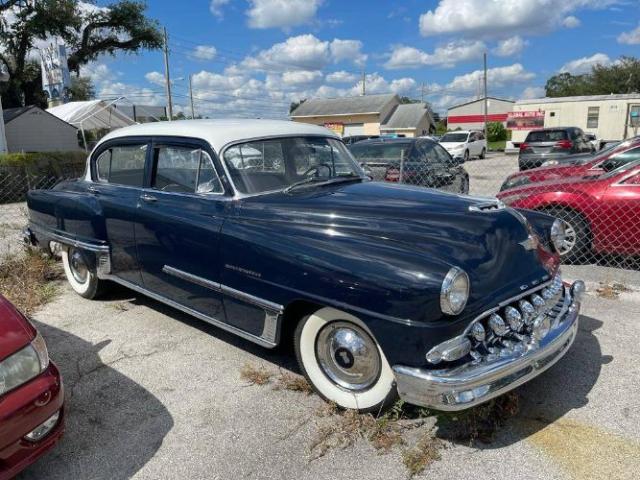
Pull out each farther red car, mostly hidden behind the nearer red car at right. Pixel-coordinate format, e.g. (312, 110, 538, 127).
(500, 137, 640, 191)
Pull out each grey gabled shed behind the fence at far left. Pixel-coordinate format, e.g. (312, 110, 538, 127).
(2, 105, 80, 152)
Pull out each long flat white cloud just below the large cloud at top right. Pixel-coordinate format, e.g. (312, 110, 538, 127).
(384, 41, 486, 70)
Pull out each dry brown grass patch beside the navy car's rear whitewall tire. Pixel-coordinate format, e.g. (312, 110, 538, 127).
(0, 249, 62, 315)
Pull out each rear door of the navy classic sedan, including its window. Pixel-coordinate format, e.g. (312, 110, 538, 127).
(88, 138, 150, 285)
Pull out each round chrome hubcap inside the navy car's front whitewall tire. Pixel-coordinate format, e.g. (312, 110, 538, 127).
(316, 321, 381, 391)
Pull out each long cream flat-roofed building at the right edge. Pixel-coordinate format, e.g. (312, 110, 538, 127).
(512, 93, 640, 144)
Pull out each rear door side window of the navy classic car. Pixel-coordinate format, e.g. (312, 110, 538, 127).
(96, 144, 147, 187)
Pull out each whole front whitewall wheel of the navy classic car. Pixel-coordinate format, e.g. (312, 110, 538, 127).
(294, 308, 398, 412)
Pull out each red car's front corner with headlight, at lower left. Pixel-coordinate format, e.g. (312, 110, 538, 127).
(0, 295, 64, 480)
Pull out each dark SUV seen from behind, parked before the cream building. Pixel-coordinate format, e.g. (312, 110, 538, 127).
(518, 127, 594, 170)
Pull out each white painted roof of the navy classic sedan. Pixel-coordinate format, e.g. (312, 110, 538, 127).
(98, 118, 340, 153)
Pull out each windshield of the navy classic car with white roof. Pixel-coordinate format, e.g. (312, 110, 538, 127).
(223, 137, 365, 194)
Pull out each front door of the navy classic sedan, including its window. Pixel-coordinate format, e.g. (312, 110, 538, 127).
(136, 139, 232, 321)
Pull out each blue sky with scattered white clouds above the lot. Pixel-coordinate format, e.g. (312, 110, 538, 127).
(84, 0, 640, 117)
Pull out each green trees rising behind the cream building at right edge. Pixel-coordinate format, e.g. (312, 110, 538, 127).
(545, 57, 640, 97)
